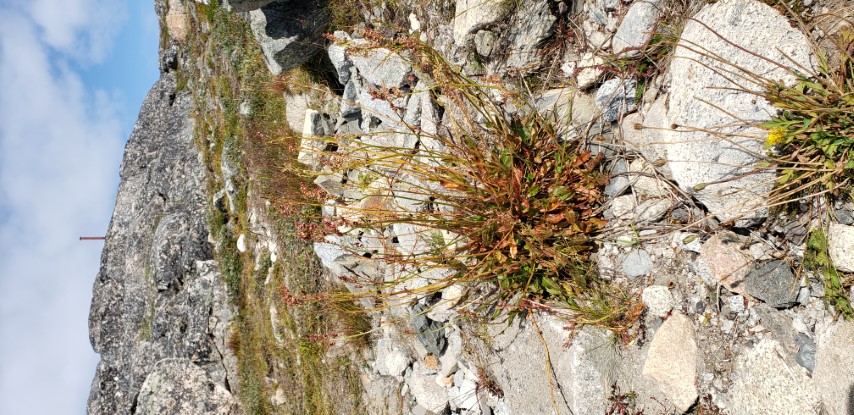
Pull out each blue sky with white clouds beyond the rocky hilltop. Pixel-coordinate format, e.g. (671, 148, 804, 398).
(0, 0, 158, 415)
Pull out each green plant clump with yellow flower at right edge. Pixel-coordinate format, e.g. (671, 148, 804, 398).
(762, 29, 854, 206)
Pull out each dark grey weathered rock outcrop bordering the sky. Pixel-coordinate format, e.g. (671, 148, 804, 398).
(88, 73, 235, 415)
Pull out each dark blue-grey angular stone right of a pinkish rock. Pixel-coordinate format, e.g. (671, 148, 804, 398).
(744, 260, 800, 308)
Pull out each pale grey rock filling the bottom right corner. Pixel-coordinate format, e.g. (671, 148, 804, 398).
(813, 321, 854, 415)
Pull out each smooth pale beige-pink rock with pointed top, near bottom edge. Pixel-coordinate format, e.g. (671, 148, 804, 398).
(643, 313, 698, 413)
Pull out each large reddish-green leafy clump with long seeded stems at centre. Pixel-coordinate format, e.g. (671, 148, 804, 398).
(302, 30, 637, 331)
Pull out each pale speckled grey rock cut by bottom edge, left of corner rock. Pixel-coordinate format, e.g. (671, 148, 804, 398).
(726, 339, 824, 415)
